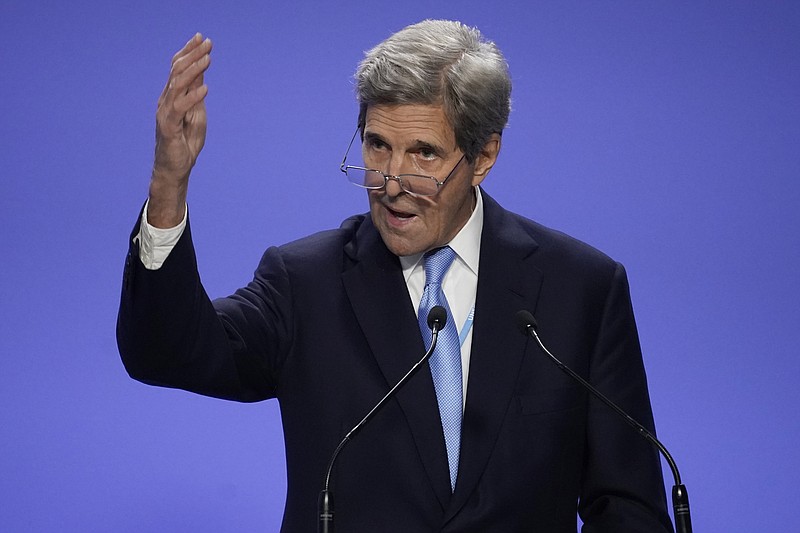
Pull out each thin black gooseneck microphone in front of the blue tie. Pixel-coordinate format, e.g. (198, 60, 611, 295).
(317, 305, 447, 533)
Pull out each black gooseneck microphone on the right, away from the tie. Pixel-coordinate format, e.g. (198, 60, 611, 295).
(516, 309, 692, 533)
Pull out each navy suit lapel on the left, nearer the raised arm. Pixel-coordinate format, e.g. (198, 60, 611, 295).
(342, 217, 451, 509)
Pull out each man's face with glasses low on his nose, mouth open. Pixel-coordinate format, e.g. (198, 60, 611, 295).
(362, 105, 499, 255)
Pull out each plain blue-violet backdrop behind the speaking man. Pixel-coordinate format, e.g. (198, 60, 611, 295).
(0, 0, 800, 532)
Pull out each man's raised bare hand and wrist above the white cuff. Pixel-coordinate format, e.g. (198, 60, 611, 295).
(147, 33, 211, 228)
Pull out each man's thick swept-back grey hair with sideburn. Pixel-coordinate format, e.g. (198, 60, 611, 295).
(356, 20, 511, 162)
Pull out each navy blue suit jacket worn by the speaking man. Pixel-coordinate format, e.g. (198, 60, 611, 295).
(117, 193, 671, 533)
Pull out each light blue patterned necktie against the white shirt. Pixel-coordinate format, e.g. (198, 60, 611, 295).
(419, 246, 463, 491)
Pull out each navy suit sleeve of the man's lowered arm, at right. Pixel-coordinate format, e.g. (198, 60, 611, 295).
(579, 264, 672, 533)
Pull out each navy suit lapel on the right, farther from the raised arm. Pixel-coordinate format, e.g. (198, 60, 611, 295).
(445, 192, 542, 520)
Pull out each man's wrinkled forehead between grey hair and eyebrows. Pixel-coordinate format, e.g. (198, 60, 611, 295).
(364, 104, 456, 150)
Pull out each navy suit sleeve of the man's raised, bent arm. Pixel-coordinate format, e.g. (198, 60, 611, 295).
(117, 210, 290, 402)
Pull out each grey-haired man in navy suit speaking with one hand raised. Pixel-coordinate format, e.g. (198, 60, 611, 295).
(117, 21, 671, 533)
